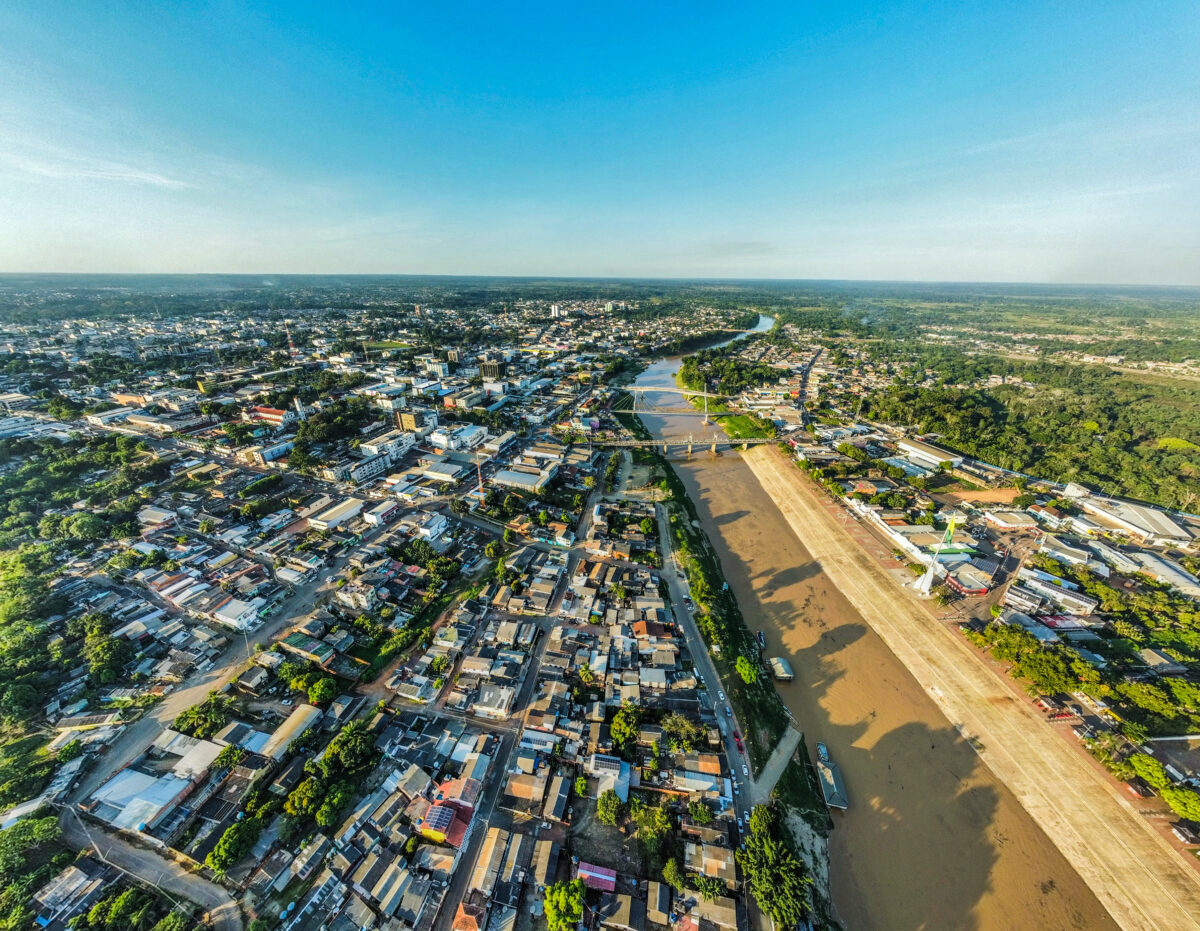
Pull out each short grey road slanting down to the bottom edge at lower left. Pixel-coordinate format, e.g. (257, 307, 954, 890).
(59, 806, 242, 931)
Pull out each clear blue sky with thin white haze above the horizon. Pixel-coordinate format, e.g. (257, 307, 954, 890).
(0, 0, 1200, 284)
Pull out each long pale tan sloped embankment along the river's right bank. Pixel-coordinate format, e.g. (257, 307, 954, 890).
(744, 446, 1200, 931)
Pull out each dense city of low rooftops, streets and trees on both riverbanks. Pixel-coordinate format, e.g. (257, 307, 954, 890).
(7, 282, 1200, 931)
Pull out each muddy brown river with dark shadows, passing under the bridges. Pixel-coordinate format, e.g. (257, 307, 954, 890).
(637, 335, 1114, 931)
